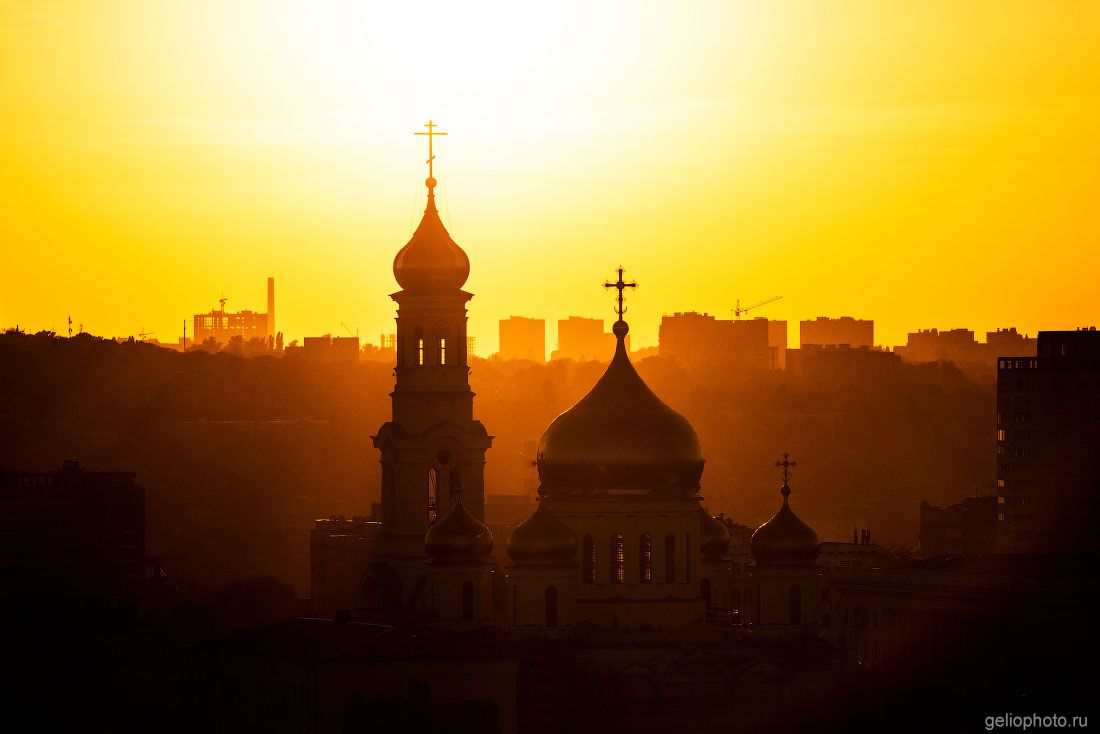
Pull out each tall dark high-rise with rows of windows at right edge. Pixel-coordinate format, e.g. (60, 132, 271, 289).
(997, 327, 1100, 554)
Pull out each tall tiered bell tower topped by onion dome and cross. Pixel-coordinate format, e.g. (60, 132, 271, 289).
(373, 121, 493, 576)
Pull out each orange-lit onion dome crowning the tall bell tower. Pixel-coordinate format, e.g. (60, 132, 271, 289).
(394, 178, 470, 293)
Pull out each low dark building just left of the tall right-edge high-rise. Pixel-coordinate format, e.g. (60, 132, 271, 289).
(917, 496, 997, 558)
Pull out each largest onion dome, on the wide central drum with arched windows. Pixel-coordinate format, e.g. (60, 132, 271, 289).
(538, 319, 703, 494)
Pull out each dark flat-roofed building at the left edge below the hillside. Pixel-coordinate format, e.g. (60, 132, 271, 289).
(0, 459, 145, 602)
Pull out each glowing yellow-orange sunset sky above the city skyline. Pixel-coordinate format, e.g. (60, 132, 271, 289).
(0, 0, 1100, 354)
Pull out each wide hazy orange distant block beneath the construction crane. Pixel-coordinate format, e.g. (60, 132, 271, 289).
(659, 311, 787, 370)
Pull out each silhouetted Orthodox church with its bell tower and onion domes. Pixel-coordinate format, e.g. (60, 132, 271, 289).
(358, 140, 818, 636)
